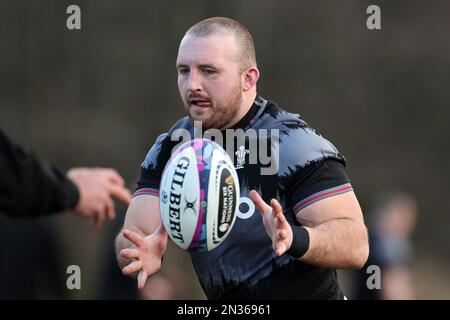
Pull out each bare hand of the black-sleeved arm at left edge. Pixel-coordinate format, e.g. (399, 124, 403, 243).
(67, 168, 131, 229)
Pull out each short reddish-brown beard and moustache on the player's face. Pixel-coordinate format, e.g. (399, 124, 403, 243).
(183, 82, 242, 130)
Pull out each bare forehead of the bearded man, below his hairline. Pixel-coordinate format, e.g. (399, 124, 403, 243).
(177, 34, 238, 63)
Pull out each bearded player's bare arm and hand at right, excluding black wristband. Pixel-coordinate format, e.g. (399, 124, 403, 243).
(250, 190, 369, 268)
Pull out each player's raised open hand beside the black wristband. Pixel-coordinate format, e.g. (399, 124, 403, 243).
(250, 190, 292, 256)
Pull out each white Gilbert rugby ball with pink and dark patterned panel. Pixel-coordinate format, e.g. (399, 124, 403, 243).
(159, 139, 240, 252)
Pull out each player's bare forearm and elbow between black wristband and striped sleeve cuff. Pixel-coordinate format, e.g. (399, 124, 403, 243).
(296, 191, 369, 268)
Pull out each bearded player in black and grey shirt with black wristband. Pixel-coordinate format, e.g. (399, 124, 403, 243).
(116, 17, 368, 299)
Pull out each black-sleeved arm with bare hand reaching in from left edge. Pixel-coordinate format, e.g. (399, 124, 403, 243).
(0, 131, 131, 227)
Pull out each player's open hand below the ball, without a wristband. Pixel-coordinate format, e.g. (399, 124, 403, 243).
(120, 224, 167, 289)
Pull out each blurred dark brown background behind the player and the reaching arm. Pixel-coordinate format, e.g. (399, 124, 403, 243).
(0, 0, 450, 299)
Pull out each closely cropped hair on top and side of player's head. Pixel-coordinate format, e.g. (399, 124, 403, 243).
(185, 17, 256, 68)
